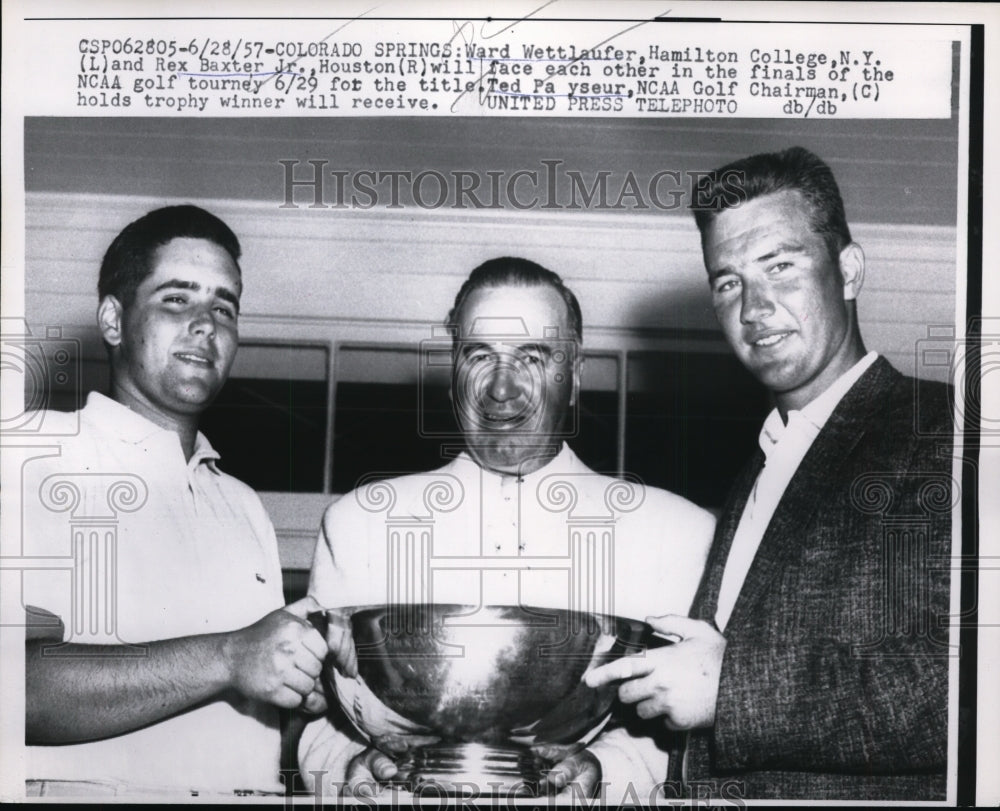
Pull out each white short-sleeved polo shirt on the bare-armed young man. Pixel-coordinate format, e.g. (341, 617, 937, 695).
(22, 393, 284, 792)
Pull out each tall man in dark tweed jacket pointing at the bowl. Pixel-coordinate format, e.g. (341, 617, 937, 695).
(588, 148, 957, 800)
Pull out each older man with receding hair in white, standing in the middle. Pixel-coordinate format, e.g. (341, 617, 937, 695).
(299, 257, 714, 802)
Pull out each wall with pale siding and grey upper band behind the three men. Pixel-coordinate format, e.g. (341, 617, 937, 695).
(25, 117, 958, 569)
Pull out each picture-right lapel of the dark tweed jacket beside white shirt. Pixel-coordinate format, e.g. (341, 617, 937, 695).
(713, 357, 899, 629)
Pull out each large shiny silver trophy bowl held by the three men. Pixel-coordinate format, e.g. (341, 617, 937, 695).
(314, 604, 656, 796)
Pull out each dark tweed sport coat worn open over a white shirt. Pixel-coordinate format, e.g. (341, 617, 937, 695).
(684, 358, 958, 800)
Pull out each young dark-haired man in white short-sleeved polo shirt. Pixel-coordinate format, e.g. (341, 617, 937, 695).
(22, 205, 327, 797)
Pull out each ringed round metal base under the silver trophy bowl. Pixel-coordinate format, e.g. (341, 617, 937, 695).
(398, 743, 548, 797)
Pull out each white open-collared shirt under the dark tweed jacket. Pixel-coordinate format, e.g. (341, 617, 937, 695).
(715, 352, 878, 632)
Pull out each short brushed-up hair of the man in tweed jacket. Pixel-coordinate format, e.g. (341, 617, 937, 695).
(691, 146, 851, 259)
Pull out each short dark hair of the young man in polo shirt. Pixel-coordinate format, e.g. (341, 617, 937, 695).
(97, 205, 240, 307)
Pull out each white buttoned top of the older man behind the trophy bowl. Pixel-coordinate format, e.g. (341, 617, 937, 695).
(299, 446, 715, 797)
